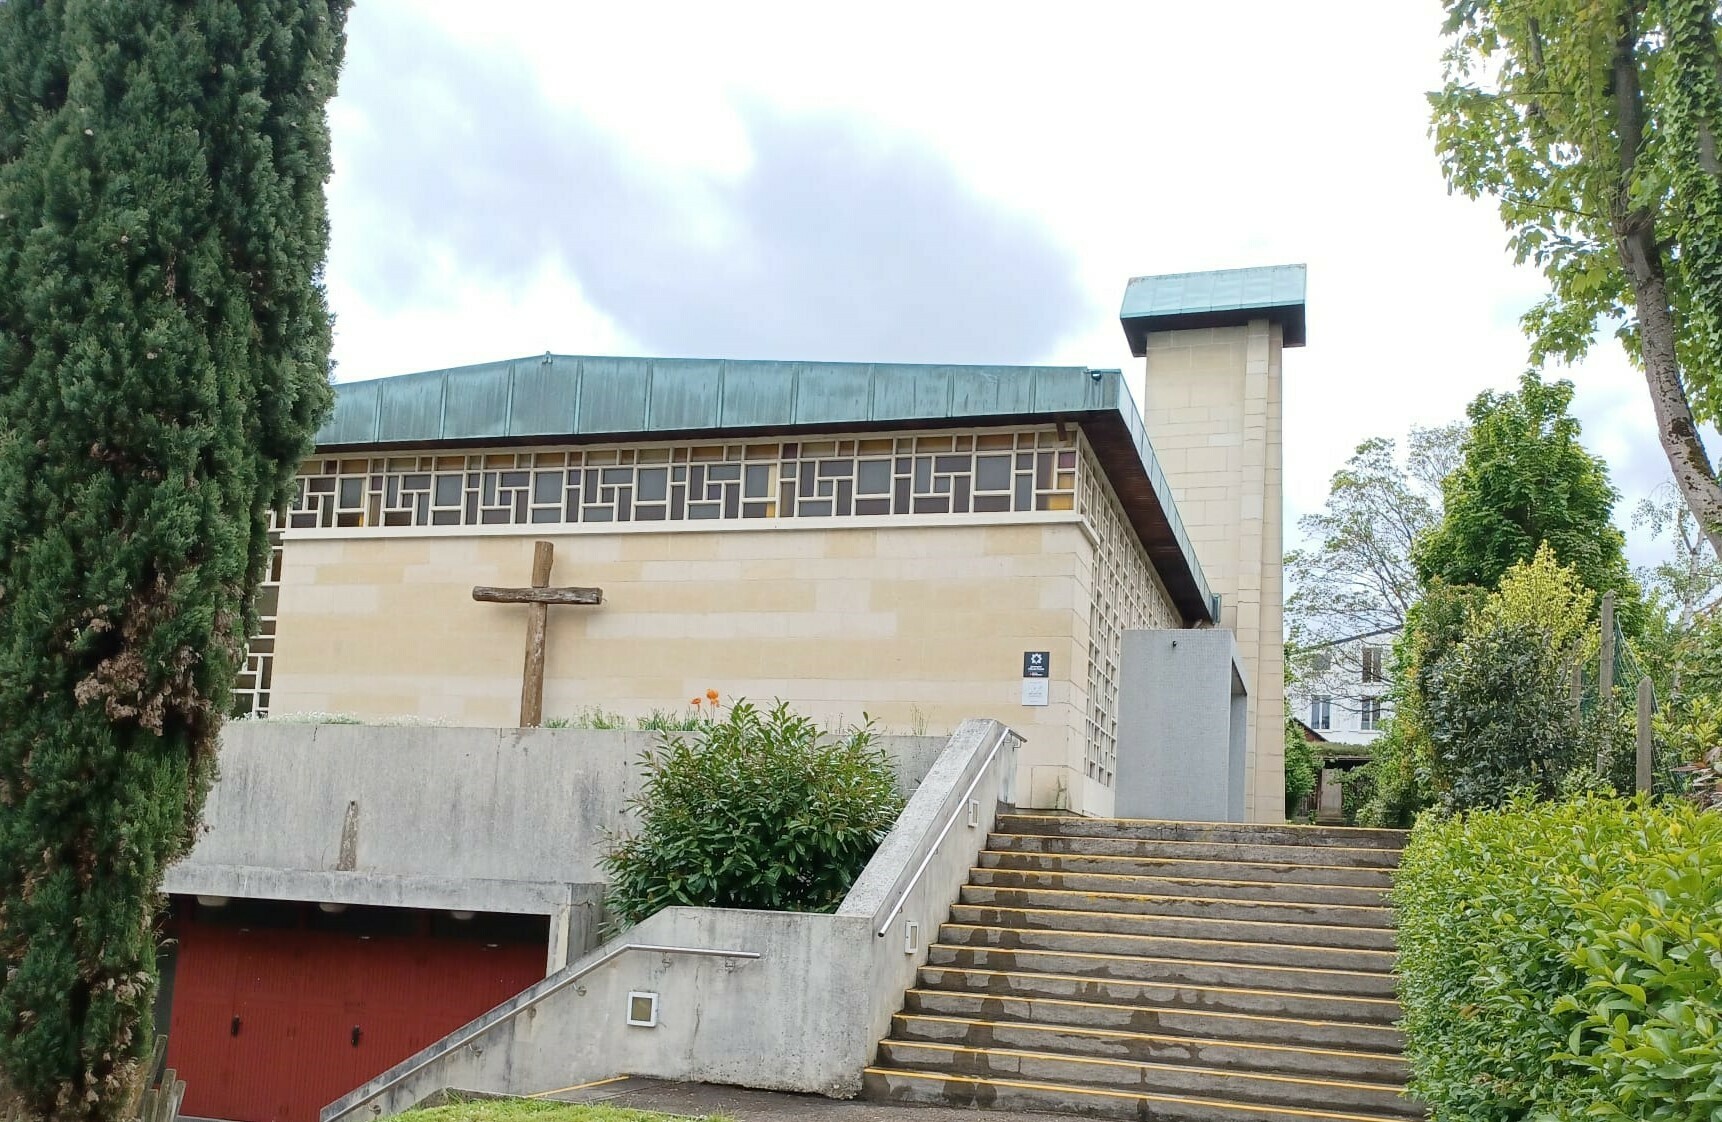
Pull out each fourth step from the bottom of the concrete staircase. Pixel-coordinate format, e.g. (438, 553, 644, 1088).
(904, 989, 1405, 1070)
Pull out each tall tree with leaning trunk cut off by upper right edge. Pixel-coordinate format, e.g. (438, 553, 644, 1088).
(1431, 0, 1722, 557)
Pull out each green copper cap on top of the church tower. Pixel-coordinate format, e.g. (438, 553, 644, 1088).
(1118, 265, 1307, 358)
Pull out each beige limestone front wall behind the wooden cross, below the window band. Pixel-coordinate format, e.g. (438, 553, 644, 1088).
(261, 513, 1111, 814)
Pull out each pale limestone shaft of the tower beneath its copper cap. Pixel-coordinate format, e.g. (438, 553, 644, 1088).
(1143, 318, 1285, 823)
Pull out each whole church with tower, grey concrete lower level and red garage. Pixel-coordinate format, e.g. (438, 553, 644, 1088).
(162, 265, 1305, 1122)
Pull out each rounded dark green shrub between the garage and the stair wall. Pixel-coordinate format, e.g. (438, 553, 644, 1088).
(604, 700, 902, 924)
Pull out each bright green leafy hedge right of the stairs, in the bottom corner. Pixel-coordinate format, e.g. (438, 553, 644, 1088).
(1393, 795, 1722, 1122)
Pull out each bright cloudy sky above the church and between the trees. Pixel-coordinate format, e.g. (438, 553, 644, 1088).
(329, 0, 1667, 559)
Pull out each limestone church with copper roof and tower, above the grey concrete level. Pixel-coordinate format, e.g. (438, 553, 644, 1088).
(239, 267, 1304, 821)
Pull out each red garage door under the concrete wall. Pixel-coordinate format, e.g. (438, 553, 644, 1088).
(167, 900, 544, 1122)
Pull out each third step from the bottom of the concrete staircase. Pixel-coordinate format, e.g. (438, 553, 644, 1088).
(885, 1014, 1410, 1088)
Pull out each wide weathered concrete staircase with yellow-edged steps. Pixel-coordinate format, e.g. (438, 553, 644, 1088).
(864, 816, 1424, 1122)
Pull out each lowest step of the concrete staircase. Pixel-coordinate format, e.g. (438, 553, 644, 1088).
(863, 1067, 1407, 1122)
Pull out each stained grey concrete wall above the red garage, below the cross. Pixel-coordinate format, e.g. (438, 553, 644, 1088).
(167, 721, 945, 914)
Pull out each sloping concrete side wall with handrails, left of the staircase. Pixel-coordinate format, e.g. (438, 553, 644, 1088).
(322, 721, 1018, 1122)
